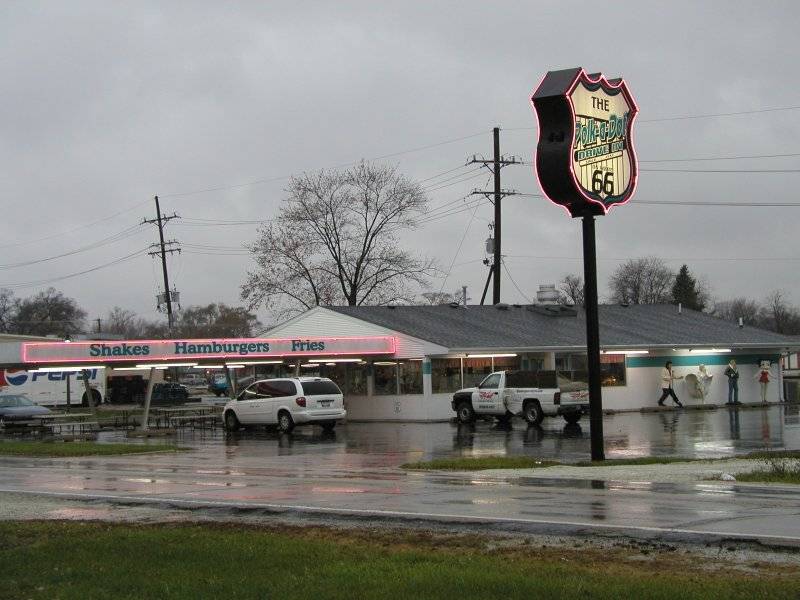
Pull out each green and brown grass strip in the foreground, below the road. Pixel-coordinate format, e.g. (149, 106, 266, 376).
(0, 522, 800, 600)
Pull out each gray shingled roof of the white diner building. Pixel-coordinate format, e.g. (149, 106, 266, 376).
(328, 304, 800, 349)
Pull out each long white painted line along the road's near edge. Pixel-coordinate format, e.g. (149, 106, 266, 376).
(0, 488, 800, 542)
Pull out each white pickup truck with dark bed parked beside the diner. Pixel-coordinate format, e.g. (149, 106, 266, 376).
(451, 371, 589, 425)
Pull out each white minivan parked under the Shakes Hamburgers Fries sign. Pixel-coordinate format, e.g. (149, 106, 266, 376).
(222, 377, 347, 433)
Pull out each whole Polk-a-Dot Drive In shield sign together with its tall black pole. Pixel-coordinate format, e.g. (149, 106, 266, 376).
(531, 68, 639, 460)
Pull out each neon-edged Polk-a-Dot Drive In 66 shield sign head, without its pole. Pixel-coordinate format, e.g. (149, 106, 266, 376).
(531, 68, 638, 217)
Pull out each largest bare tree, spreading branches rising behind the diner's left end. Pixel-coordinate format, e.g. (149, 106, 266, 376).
(242, 163, 435, 316)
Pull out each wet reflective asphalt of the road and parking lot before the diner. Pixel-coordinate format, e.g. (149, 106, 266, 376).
(0, 405, 800, 544)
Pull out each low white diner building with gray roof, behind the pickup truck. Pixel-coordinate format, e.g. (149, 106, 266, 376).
(269, 303, 800, 421)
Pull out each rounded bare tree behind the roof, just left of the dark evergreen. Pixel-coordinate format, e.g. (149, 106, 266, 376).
(609, 256, 675, 304)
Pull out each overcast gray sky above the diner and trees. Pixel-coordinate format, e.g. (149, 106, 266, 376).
(0, 0, 800, 322)
